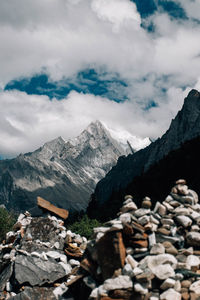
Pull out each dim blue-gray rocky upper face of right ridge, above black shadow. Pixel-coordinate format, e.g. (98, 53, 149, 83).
(93, 90, 200, 205)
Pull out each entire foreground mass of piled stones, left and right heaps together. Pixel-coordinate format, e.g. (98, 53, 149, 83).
(0, 179, 200, 300)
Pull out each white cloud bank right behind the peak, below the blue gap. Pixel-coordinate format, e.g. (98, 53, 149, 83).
(0, 89, 187, 157)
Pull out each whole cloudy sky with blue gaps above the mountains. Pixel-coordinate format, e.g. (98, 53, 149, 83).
(0, 0, 200, 157)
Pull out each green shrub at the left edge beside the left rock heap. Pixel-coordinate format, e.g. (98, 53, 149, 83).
(0, 207, 16, 242)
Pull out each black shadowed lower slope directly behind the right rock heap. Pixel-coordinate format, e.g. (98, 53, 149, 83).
(87, 136, 200, 221)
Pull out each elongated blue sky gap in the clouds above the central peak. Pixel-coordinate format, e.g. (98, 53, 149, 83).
(5, 69, 128, 102)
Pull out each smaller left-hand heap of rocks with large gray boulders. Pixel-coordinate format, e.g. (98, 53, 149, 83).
(0, 212, 87, 300)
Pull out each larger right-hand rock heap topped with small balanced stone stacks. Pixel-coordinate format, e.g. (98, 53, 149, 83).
(81, 180, 200, 300)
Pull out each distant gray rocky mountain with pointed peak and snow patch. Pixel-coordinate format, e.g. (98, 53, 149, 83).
(0, 121, 150, 211)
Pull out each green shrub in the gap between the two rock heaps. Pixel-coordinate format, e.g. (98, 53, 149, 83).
(67, 215, 101, 239)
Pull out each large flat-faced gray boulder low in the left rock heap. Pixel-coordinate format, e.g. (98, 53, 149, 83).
(15, 255, 66, 286)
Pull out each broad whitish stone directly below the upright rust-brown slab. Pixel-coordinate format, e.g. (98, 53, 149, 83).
(103, 275, 133, 291)
